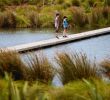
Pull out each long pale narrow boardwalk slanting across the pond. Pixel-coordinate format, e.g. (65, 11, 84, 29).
(7, 27, 110, 52)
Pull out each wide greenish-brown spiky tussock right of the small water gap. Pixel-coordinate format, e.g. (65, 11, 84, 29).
(56, 53, 98, 84)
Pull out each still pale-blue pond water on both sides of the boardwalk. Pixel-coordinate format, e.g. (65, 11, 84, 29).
(0, 29, 110, 86)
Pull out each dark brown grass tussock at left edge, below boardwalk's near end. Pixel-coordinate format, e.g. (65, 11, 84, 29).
(0, 50, 26, 80)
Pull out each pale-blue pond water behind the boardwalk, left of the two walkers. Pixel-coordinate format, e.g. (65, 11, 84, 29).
(0, 29, 55, 47)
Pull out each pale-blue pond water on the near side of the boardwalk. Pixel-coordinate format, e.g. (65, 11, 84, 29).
(36, 34, 110, 86)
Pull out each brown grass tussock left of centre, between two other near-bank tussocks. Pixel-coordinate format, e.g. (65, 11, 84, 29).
(25, 54, 54, 83)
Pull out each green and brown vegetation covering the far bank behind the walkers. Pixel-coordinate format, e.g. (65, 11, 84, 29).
(0, 0, 110, 29)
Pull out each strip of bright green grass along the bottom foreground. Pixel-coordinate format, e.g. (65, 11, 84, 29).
(0, 75, 110, 100)
